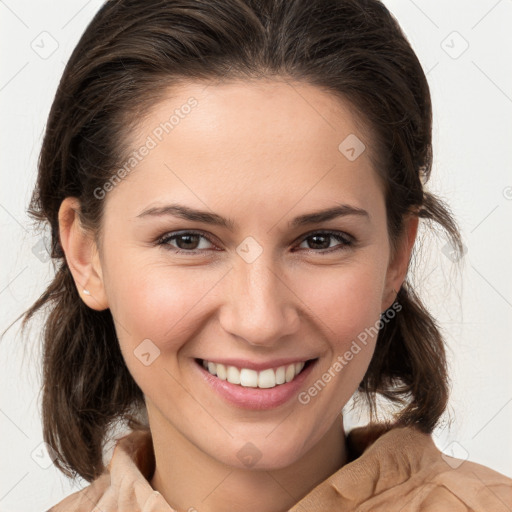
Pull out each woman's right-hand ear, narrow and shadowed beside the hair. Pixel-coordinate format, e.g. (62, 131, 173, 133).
(381, 212, 419, 311)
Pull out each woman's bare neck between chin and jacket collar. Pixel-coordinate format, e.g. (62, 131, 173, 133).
(151, 415, 347, 512)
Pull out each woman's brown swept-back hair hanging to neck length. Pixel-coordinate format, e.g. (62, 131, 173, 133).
(9, 0, 462, 481)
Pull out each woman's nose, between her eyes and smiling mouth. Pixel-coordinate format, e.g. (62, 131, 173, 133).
(220, 251, 300, 347)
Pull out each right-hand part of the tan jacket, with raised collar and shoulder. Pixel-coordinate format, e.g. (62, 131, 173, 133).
(300, 425, 512, 512)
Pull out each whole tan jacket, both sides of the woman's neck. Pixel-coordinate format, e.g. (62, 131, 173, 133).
(49, 425, 512, 512)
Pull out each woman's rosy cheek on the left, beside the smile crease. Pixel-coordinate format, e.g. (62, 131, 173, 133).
(104, 262, 222, 402)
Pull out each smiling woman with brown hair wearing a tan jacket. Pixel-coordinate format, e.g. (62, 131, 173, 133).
(17, 0, 512, 512)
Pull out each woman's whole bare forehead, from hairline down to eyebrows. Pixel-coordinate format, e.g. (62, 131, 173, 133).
(107, 80, 380, 222)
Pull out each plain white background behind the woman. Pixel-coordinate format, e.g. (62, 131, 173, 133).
(0, 0, 512, 512)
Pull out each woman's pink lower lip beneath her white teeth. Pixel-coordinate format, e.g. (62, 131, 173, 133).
(194, 360, 317, 410)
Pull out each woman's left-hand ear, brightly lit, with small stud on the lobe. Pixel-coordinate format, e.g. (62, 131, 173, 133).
(59, 197, 108, 311)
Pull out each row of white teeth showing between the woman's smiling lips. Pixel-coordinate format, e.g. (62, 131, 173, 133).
(196, 359, 316, 389)
